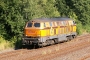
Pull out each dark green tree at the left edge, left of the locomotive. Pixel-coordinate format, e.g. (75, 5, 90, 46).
(0, 0, 24, 38)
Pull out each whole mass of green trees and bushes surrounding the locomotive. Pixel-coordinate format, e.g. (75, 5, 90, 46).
(0, 0, 90, 49)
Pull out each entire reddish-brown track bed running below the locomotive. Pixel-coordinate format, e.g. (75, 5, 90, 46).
(0, 34, 90, 60)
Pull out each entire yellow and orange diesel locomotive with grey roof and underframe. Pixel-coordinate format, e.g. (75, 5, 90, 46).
(23, 18, 77, 46)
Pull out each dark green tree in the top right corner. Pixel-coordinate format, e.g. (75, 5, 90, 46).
(67, 0, 90, 25)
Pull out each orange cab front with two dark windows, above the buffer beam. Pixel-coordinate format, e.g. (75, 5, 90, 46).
(24, 22, 43, 37)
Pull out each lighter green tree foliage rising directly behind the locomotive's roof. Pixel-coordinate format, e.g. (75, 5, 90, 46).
(23, 0, 60, 20)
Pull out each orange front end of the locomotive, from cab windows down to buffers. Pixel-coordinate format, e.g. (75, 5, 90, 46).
(22, 21, 44, 45)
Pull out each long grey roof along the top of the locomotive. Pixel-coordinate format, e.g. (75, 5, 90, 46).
(30, 18, 73, 22)
